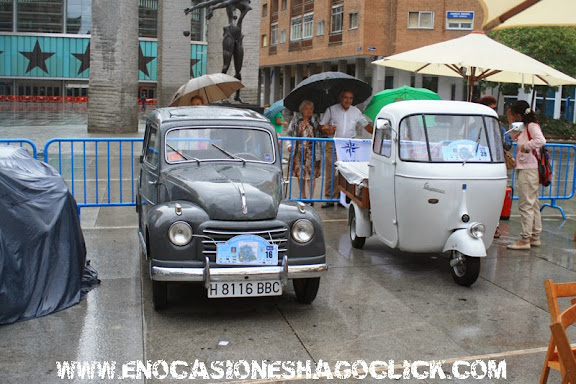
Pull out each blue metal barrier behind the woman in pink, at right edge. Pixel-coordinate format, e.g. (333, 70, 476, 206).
(511, 143, 576, 219)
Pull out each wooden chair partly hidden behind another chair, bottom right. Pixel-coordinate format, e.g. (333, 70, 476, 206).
(540, 280, 576, 384)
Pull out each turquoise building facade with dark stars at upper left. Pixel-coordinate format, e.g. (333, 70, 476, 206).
(0, 0, 207, 102)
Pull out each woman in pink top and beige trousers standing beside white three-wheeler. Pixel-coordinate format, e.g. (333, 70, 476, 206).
(507, 100, 546, 250)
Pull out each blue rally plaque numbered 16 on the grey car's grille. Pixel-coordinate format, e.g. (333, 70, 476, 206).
(216, 235, 278, 265)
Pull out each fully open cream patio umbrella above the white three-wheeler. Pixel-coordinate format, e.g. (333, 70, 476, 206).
(372, 31, 576, 100)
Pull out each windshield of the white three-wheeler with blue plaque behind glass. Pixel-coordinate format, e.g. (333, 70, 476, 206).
(399, 114, 504, 163)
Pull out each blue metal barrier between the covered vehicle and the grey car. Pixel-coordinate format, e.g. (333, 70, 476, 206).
(44, 138, 143, 208)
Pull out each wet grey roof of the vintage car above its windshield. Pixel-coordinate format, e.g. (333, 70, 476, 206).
(150, 105, 270, 124)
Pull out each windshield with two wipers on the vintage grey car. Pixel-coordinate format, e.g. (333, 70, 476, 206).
(165, 127, 275, 163)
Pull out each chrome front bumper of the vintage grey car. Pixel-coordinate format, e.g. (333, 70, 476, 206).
(150, 256, 328, 287)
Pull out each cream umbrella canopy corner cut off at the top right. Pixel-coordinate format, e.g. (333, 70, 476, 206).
(479, 0, 576, 31)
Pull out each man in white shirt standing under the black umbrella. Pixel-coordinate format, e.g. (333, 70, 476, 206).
(318, 90, 372, 208)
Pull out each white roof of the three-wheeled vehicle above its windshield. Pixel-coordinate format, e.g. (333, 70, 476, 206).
(379, 100, 498, 119)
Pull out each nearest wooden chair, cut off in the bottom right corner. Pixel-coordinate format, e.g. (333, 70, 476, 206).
(550, 304, 576, 384)
